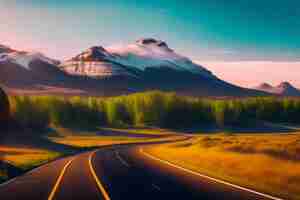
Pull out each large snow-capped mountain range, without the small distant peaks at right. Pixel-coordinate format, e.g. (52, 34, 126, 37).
(0, 38, 266, 97)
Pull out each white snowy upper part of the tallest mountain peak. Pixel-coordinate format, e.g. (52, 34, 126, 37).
(107, 38, 214, 77)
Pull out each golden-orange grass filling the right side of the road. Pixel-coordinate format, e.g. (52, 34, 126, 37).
(147, 134, 300, 199)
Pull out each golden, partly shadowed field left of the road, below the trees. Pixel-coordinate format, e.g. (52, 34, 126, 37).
(0, 127, 178, 182)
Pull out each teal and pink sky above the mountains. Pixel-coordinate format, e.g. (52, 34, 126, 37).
(0, 0, 300, 88)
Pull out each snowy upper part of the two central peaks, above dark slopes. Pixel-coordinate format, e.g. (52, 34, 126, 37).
(61, 38, 215, 78)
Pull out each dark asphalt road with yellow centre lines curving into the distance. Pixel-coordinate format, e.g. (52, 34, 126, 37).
(0, 145, 279, 200)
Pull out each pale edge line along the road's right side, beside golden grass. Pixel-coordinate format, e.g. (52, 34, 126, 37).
(140, 148, 283, 200)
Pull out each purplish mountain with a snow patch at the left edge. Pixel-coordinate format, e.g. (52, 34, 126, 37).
(0, 46, 65, 85)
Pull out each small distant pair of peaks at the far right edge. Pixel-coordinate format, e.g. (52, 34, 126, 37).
(255, 82, 300, 96)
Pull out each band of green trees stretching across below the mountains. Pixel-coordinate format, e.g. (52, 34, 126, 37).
(10, 91, 300, 128)
